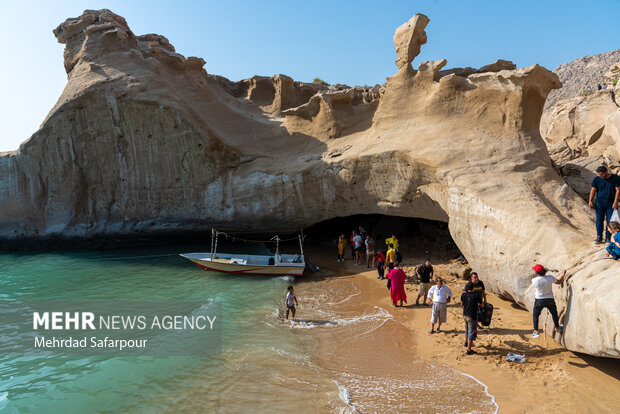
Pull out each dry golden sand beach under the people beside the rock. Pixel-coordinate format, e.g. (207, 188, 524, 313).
(306, 249, 620, 413)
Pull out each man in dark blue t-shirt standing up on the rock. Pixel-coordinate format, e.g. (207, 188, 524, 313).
(589, 165, 620, 243)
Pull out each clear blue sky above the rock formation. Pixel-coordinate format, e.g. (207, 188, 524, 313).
(0, 0, 620, 151)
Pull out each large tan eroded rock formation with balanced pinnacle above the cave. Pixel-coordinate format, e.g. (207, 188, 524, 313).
(0, 10, 620, 357)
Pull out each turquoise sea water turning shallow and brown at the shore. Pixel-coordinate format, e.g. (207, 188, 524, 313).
(0, 246, 495, 413)
